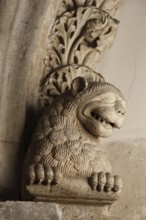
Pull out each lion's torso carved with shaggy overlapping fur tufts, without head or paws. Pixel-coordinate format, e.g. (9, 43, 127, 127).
(26, 88, 111, 176)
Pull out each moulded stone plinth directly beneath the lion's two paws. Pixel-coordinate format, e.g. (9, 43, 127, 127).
(26, 177, 119, 206)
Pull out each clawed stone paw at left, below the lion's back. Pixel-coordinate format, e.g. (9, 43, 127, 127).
(25, 164, 62, 185)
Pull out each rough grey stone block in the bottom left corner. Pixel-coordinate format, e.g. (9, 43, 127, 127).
(0, 202, 62, 220)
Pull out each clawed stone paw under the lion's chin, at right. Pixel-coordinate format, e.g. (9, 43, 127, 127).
(89, 172, 123, 192)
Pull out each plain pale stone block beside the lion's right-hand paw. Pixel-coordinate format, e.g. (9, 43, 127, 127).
(105, 138, 146, 220)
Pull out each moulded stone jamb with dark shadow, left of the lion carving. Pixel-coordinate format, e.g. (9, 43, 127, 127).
(0, 0, 60, 199)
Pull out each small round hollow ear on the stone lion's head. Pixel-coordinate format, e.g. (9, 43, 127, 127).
(71, 76, 88, 92)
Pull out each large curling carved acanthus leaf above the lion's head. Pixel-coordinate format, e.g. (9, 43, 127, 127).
(44, 6, 118, 77)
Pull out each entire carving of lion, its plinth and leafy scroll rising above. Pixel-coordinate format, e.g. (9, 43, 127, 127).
(24, 0, 126, 206)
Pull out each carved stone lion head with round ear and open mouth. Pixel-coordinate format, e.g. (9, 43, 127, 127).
(71, 77, 126, 137)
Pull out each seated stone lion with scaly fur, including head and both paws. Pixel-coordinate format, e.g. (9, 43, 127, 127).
(25, 73, 126, 192)
